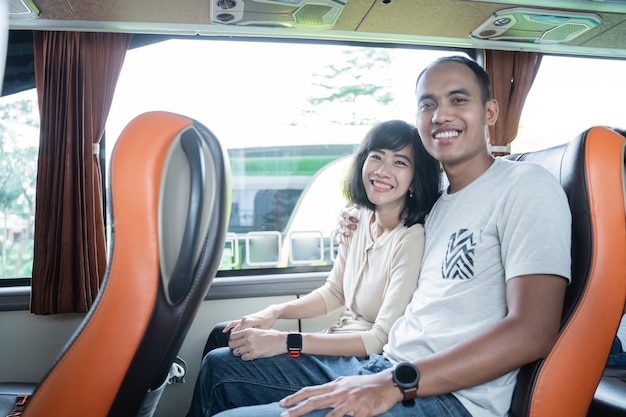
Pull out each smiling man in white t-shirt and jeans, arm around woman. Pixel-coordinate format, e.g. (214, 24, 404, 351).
(204, 57, 571, 417)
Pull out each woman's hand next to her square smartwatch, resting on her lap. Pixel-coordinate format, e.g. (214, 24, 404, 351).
(228, 329, 287, 361)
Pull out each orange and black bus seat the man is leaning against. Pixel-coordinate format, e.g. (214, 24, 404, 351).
(507, 127, 626, 417)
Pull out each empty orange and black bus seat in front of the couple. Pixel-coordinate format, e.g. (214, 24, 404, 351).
(0, 112, 230, 417)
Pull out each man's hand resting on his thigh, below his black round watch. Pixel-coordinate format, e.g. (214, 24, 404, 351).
(280, 369, 402, 417)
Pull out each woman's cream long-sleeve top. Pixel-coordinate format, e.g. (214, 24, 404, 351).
(315, 208, 424, 355)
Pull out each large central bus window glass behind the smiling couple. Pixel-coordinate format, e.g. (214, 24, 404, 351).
(107, 39, 451, 275)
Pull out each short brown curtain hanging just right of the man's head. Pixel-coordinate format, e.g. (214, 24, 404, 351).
(485, 50, 543, 156)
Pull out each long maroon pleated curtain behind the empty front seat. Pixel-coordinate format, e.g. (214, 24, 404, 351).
(30, 31, 132, 314)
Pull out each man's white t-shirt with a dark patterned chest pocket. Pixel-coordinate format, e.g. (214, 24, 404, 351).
(384, 158, 571, 417)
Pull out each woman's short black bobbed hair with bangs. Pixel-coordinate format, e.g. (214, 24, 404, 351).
(344, 120, 441, 227)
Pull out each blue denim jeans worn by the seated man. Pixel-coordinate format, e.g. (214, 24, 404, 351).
(188, 348, 470, 417)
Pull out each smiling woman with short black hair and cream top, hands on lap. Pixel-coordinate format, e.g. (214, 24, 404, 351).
(204, 120, 440, 360)
